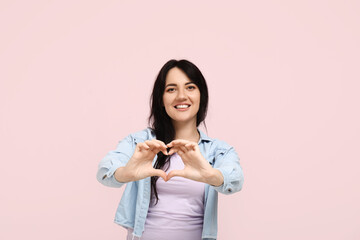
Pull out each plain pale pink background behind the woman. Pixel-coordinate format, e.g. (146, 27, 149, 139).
(0, 0, 360, 240)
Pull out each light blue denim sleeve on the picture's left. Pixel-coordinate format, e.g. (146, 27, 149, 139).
(96, 135, 135, 188)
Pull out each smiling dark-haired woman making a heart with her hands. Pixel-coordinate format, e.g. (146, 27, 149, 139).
(97, 60, 244, 240)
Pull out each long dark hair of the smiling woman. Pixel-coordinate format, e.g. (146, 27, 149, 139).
(148, 59, 209, 204)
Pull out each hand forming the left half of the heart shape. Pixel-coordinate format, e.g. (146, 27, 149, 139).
(114, 139, 168, 182)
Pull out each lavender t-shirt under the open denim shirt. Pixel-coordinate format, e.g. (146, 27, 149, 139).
(128, 153, 205, 240)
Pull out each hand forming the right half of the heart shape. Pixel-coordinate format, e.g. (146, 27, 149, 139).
(167, 139, 224, 186)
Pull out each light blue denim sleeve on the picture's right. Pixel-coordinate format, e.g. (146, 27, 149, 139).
(213, 147, 244, 194)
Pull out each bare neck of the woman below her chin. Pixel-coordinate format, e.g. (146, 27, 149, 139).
(173, 118, 200, 143)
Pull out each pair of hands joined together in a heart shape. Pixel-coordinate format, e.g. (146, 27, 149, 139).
(126, 139, 224, 186)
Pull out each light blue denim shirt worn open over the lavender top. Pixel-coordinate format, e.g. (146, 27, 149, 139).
(96, 128, 244, 240)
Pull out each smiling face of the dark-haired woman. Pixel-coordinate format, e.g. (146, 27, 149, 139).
(163, 67, 200, 124)
